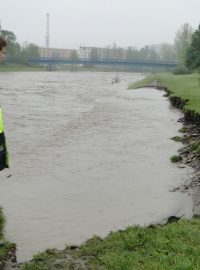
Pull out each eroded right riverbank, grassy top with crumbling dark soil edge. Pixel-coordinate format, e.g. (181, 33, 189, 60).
(132, 73, 200, 216)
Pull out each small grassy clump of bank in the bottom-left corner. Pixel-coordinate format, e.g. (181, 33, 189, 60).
(0, 208, 16, 270)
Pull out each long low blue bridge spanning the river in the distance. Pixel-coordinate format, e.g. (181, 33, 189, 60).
(28, 57, 178, 69)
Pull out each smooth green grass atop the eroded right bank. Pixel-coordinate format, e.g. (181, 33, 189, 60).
(130, 73, 200, 113)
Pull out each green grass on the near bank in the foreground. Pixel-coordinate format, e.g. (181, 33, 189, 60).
(22, 218, 200, 270)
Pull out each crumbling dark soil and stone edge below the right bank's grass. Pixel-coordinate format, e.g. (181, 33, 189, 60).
(153, 85, 200, 200)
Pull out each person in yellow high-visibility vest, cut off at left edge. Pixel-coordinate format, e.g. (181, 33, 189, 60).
(0, 37, 9, 171)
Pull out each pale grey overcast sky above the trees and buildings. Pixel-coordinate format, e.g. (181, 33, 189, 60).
(0, 0, 200, 49)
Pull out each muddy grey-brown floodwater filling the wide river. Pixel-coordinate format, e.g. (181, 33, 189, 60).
(0, 72, 195, 261)
